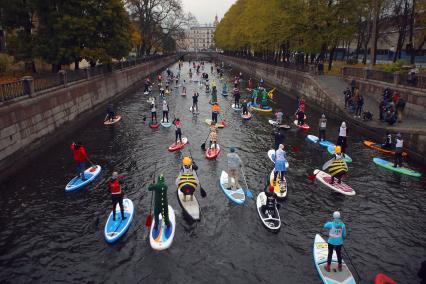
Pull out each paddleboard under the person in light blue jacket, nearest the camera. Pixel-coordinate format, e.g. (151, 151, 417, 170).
(314, 234, 356, 284)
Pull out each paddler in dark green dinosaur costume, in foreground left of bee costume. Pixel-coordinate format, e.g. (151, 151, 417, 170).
(148, 175, 170, 227)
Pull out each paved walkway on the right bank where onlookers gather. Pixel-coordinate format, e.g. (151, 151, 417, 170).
(314, 75, 426, 133)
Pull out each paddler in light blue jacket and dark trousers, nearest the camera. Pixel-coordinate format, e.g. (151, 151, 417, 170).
(324, 211, 346, 272)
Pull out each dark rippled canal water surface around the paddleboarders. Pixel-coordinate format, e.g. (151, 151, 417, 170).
(0, 62, 426, 283)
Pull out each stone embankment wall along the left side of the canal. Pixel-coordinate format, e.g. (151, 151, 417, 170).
(0, 56, 177, 178)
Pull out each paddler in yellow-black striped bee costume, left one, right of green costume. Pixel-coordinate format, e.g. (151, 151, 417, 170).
(176, 157, 200, 201)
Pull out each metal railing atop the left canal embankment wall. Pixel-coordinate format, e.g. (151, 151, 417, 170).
(0, 55, 169, 102)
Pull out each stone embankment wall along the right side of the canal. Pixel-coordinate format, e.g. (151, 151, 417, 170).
(217, 55, 426, 164)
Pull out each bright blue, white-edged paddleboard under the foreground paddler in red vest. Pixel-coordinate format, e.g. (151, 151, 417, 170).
(104, 198, 134, 243)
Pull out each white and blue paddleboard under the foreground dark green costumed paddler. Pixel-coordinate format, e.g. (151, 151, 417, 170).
(149, 205, 176, 250)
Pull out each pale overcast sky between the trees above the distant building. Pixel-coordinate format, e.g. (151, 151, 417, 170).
(182, 0, 236, 24)
